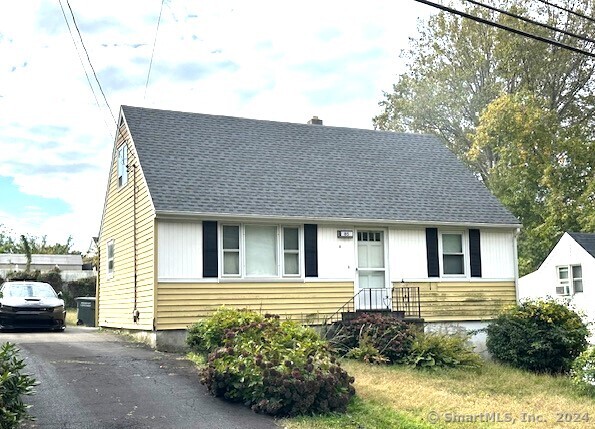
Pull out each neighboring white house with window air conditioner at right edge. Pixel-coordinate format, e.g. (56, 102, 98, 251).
(518, 232, 595, 338)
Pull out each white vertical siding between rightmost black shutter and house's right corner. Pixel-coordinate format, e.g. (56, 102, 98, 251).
(481, 229, 515, 279)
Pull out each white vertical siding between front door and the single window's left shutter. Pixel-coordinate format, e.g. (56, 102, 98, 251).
(388, 228, 428, 282)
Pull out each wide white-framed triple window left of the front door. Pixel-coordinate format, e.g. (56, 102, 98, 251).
(221, 224, 302, 278)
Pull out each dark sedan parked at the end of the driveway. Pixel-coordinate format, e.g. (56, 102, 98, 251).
(0, 281, 66, 331)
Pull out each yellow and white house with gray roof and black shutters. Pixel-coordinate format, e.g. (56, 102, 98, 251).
(97, 106, 520, 348)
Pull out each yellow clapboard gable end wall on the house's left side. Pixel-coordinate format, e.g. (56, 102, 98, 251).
(97, 126, 155, 330)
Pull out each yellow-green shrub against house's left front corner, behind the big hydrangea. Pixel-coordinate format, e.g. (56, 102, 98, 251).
(186, 307, 264, 353)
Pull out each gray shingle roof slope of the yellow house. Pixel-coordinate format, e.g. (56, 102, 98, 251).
(122, 106, 519, 225)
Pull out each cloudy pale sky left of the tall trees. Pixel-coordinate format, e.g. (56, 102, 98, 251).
(0, 0, 434, 252)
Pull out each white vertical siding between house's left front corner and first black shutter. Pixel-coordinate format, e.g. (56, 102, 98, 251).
(158, 221, 202, 279)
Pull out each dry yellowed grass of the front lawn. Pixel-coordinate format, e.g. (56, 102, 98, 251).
(344, 361, 595, 428)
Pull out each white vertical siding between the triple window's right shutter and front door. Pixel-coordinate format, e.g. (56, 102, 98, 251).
(318, 225, 356, 281)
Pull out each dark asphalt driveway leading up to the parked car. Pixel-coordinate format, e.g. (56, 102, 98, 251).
(0, 327, 278, 429)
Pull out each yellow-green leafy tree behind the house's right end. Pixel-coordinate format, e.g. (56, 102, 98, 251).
(467, 92, 595, 273)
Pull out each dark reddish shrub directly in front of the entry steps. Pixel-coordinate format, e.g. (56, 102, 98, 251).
(327, 313, 415, 363)
